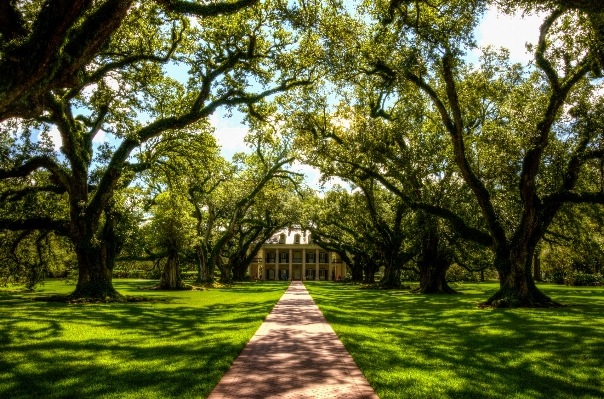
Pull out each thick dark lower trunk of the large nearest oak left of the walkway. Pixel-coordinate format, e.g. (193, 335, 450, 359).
(69, 237, 122, 300)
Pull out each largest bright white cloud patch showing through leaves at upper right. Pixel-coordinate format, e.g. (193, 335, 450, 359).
(475, 6, 545, 64)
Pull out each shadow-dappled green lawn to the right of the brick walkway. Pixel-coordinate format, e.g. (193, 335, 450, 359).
(305, 282, 604, 399)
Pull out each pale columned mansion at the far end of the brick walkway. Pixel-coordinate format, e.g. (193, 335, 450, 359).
(248, 230, 346, 280)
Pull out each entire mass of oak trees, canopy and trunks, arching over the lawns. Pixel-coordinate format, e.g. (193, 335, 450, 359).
(0, 0, 604, 306)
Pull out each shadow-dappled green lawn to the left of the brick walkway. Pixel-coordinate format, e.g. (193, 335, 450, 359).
(0, 280, 287, 399)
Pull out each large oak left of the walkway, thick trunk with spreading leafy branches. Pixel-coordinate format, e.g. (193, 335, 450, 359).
(0, 1, 313, 297)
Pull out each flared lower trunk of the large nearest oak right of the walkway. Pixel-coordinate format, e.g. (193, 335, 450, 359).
(484, 248, 562, 307)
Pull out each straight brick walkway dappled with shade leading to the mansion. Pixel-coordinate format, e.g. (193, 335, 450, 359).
(208, 281, 377, 399)
